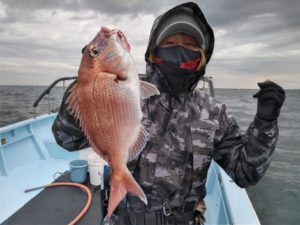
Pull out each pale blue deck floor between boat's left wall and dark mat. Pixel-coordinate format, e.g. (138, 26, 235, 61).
(0, 159, 70, 223)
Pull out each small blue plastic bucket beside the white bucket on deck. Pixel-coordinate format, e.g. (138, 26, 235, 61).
(69, 159, 88, 183)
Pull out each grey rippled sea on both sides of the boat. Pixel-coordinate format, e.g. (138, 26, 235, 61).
(0, 86, 300, 225)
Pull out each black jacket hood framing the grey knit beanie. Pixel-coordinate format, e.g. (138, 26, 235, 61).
(145, 2, 215, 69)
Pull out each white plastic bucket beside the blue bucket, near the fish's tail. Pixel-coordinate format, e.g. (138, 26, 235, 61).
(88, 153, 105, 186)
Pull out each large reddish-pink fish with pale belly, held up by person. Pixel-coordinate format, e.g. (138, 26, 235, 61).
(66, 27, 160, 218)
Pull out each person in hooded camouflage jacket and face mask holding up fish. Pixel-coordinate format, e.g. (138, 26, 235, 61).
(52, 2, 285, 225)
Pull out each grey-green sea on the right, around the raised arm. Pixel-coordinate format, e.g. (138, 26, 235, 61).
(216, 89, 300, 225)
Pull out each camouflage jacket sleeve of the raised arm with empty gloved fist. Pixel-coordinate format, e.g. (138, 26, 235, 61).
(213, 105, 278, 187)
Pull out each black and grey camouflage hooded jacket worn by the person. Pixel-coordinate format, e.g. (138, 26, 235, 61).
(52, 3, 278, 218)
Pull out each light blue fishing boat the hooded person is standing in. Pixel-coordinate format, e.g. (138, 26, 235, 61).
(0, 78, 260, 225)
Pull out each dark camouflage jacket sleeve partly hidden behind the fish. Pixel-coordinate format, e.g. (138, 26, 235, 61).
(52, 81, 90, 151)
